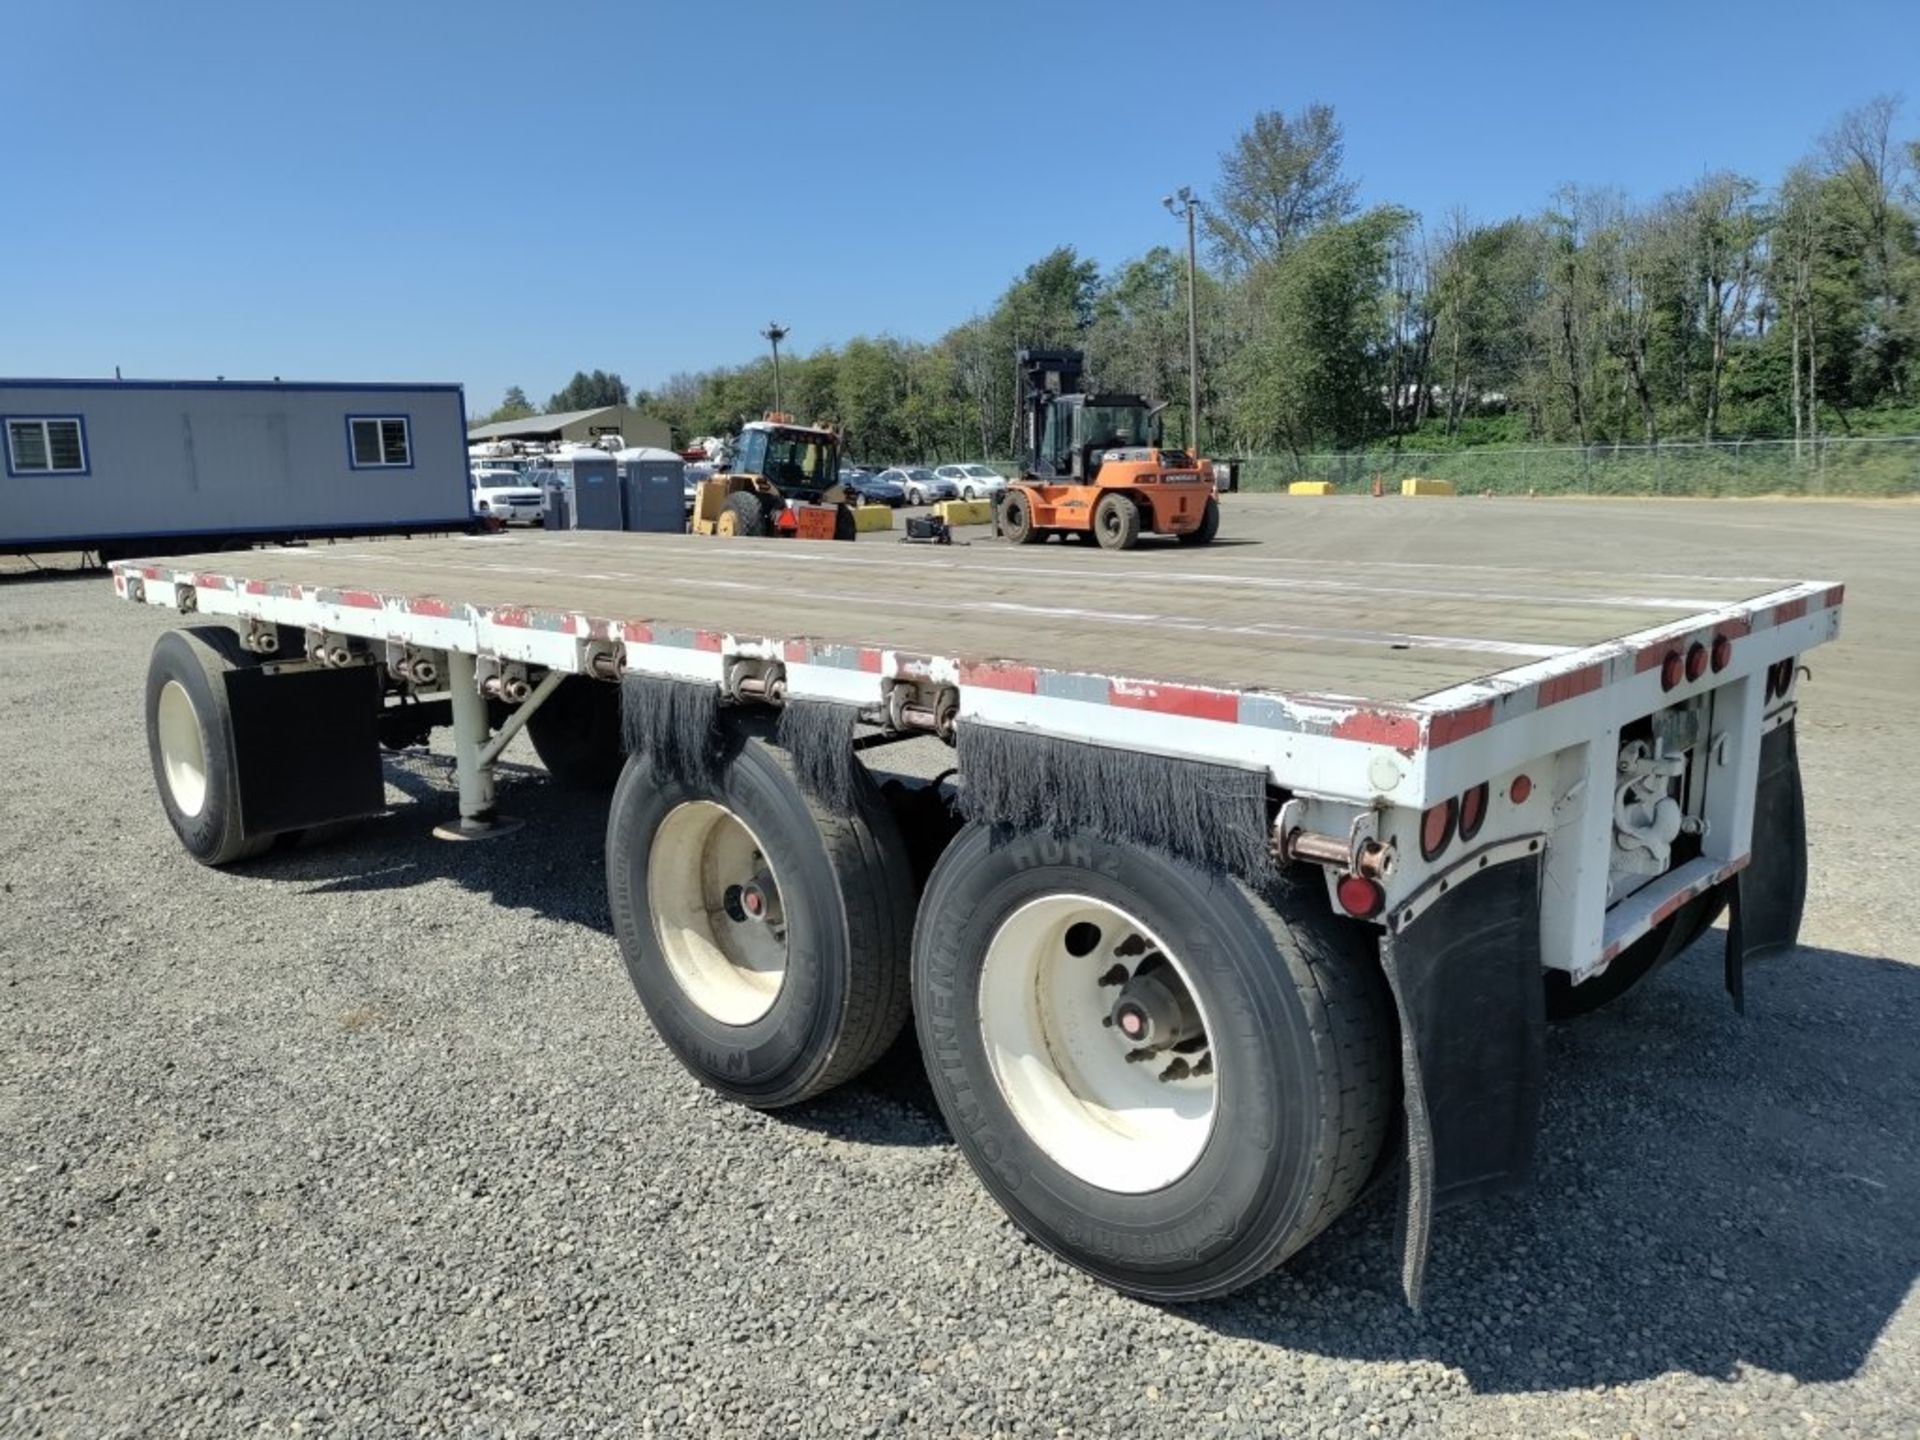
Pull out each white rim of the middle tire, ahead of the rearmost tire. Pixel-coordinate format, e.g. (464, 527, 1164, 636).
(647, 801, 787, 1025)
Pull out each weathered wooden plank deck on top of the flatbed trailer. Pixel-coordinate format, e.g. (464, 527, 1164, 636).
(123, 497, 1827, 705)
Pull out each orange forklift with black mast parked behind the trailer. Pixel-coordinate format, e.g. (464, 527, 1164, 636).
(995, 349, 1225, 549)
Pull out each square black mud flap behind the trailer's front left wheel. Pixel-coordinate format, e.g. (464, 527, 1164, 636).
(227, 664, 386, 837)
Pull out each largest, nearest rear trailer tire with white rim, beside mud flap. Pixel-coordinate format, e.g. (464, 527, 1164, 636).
(914, 824, 1398, 1302)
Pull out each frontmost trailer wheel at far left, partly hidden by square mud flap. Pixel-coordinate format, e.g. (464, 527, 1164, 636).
(146, 626, 275, 866)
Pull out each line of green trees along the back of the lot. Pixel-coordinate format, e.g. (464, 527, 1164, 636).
(472, 98, 1920, 461)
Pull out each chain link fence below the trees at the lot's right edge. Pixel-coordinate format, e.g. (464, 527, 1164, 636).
(1240, 436, 1920, 497)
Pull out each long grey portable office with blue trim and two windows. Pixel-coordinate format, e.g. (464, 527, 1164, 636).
(0, 378, 472, 559)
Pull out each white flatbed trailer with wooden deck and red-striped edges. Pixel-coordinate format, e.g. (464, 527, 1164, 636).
(113, 532, 1843, 1298)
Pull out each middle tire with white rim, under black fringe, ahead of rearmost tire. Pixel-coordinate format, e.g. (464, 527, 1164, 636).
(607, 732, 914, 1110)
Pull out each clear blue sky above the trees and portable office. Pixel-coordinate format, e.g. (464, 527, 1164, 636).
(0, 0, 1920, 409)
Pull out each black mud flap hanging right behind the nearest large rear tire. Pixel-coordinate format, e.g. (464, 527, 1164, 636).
(1380, 847, 1546, 1309)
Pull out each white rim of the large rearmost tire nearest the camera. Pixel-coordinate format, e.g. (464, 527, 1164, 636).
(979, 895, 1219, 1194)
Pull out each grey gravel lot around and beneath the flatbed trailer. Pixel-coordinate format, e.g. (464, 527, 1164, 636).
(0, 499, 1920, 1438)
